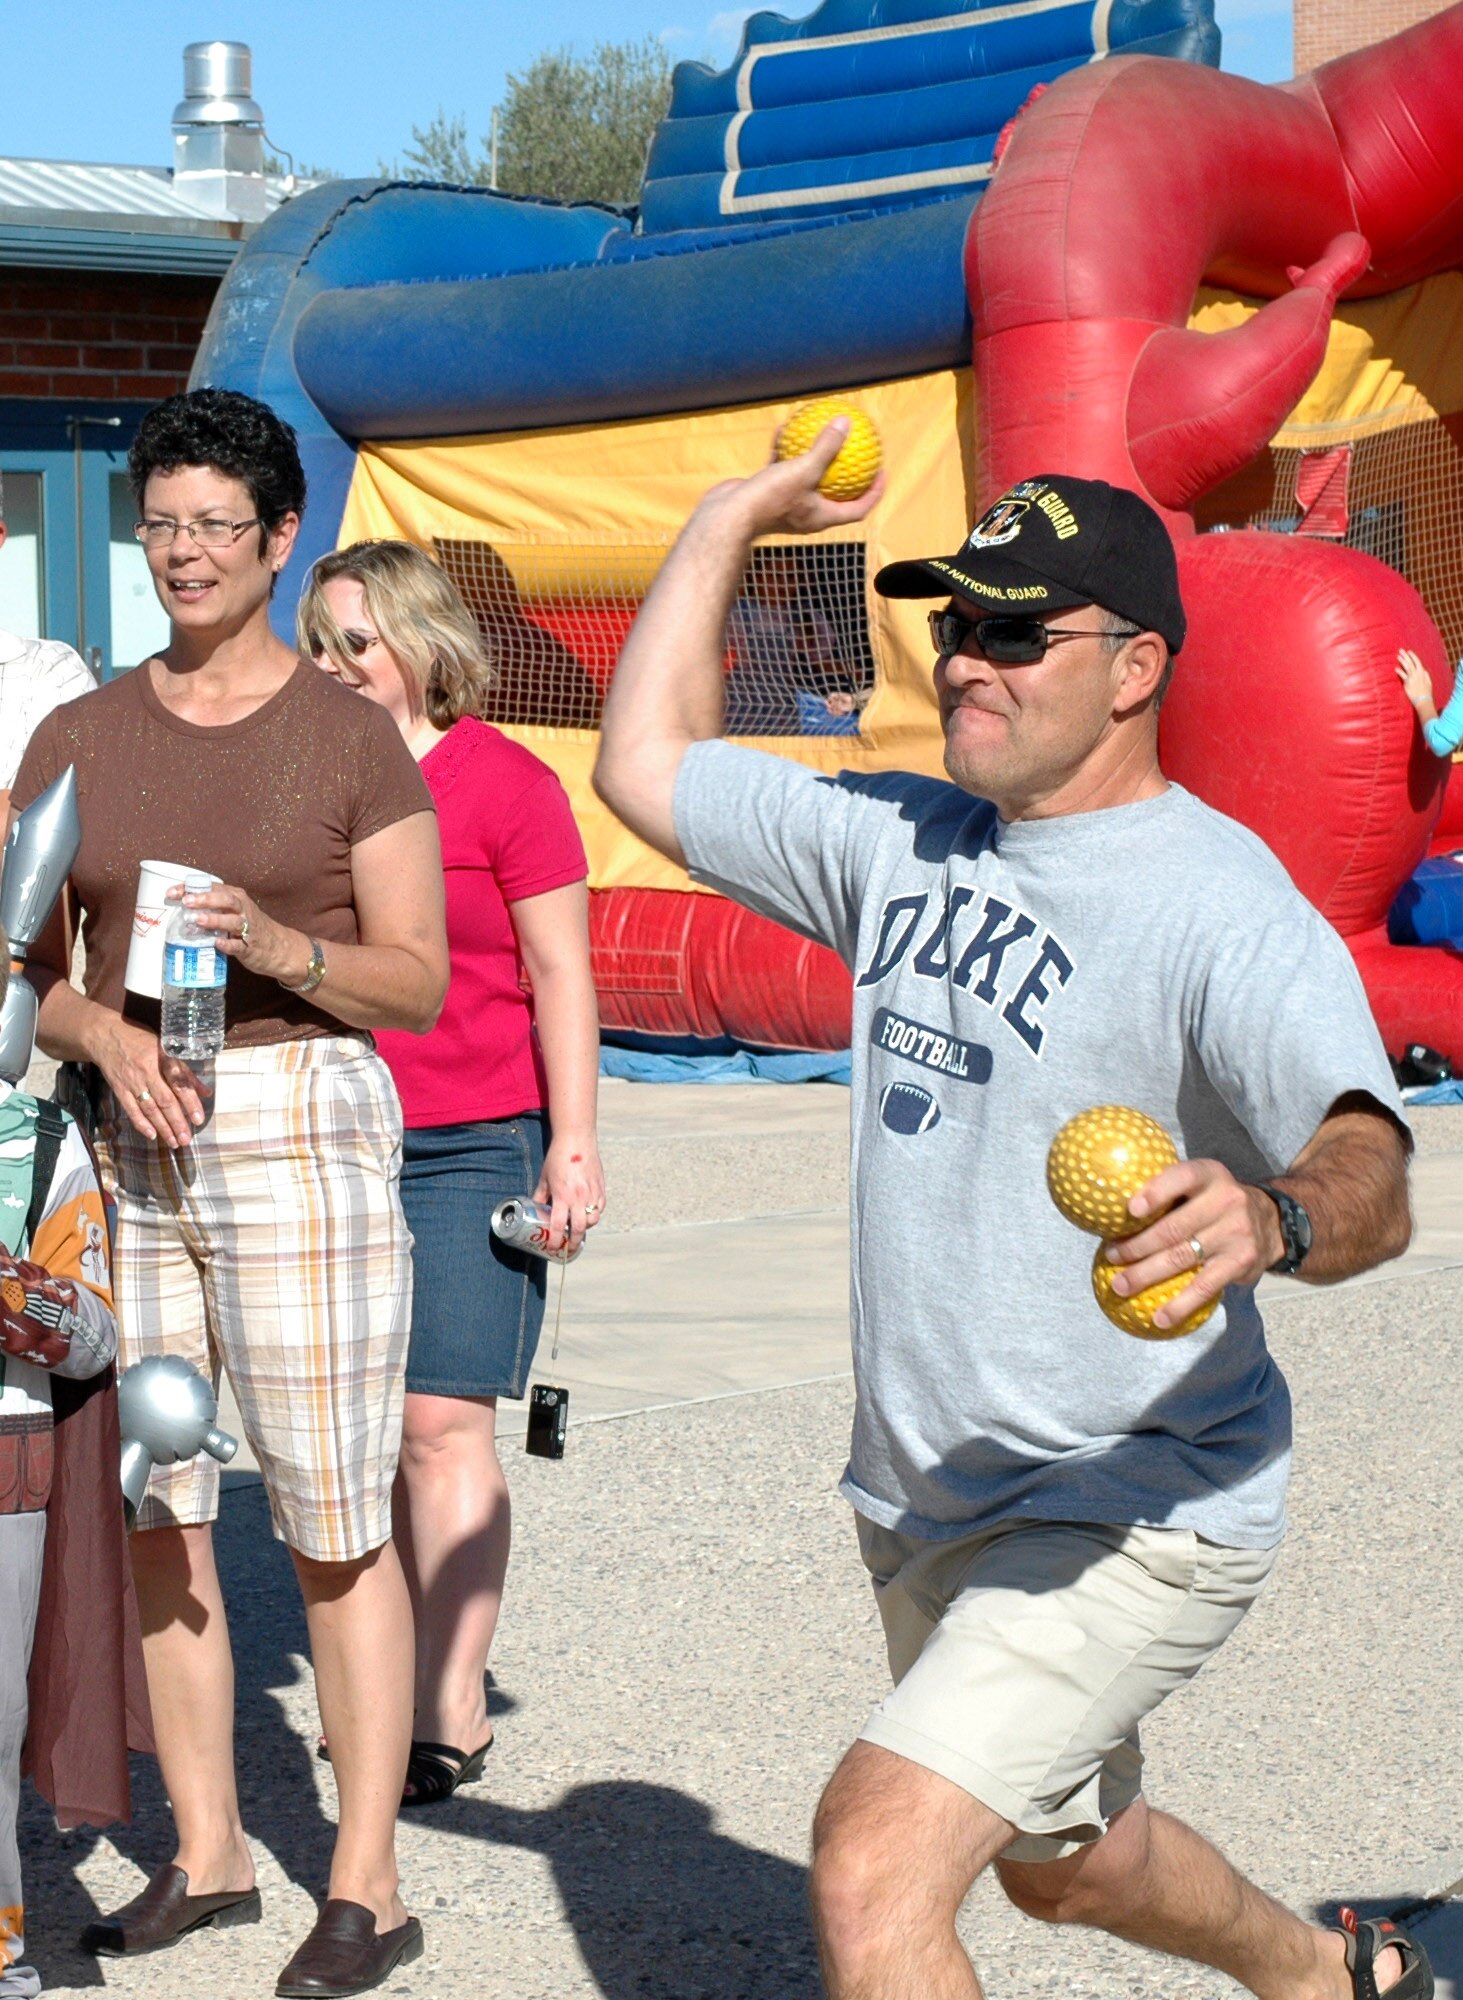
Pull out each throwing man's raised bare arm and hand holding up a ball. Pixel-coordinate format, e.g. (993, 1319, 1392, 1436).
(594, 418, 883, 862)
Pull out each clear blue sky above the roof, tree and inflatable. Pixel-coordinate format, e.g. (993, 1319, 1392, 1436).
(0, 0, 1291, 174)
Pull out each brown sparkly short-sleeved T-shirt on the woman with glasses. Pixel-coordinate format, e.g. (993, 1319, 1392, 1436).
(12, 664, 434, 1048)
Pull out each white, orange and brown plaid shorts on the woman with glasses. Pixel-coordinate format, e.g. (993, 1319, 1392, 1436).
(98, 1036, 412, 1562)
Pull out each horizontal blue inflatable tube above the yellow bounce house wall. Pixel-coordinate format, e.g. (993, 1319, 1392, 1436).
(294, 198, 973, 438)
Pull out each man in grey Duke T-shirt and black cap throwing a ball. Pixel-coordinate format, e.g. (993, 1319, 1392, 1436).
(596, 426, 1433, 2000)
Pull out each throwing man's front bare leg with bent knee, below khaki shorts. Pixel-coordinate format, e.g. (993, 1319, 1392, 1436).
(811, 1742, 1015, 2000)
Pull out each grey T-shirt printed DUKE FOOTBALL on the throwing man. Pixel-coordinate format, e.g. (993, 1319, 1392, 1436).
(676, 742, 1401, 1548)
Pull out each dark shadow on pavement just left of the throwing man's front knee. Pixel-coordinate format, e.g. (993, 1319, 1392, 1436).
(434, 1780, 821, 2000)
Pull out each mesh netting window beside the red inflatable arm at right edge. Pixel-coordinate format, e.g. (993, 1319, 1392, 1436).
(1215, 408, 1463, 660)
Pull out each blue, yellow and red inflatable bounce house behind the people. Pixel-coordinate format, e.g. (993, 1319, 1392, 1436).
(194, 0, 1463, 1064)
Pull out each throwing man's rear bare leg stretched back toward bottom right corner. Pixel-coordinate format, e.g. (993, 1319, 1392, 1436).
(999, 1798, 1401, 2000)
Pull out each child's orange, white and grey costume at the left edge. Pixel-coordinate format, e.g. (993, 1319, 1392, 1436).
(0, 1082, 116, 2000)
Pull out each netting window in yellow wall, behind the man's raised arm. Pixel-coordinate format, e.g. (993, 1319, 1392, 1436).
(434, 538, 875, 736)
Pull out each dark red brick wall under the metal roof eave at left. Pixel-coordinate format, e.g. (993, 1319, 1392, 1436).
(0, 266, 218, 402)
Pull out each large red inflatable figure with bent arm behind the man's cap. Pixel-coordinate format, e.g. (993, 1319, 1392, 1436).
(967, 6, 1463, 1060)
